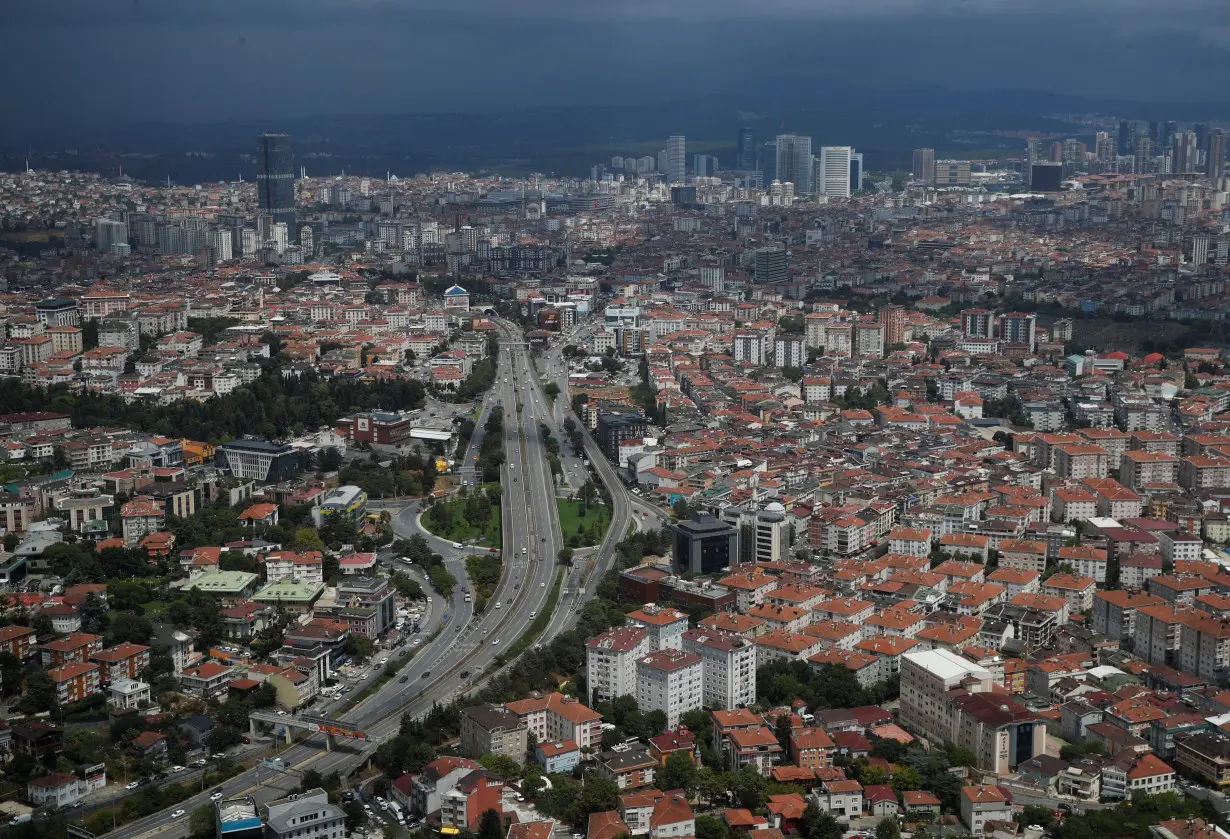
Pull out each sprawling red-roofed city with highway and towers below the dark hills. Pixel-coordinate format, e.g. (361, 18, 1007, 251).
(0, 109, 1230, 839)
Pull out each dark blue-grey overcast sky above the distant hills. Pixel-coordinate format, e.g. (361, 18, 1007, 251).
(0, 0, 1230, 127)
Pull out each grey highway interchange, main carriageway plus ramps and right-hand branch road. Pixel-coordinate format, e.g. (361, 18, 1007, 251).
(98, 324, 657, 839)
